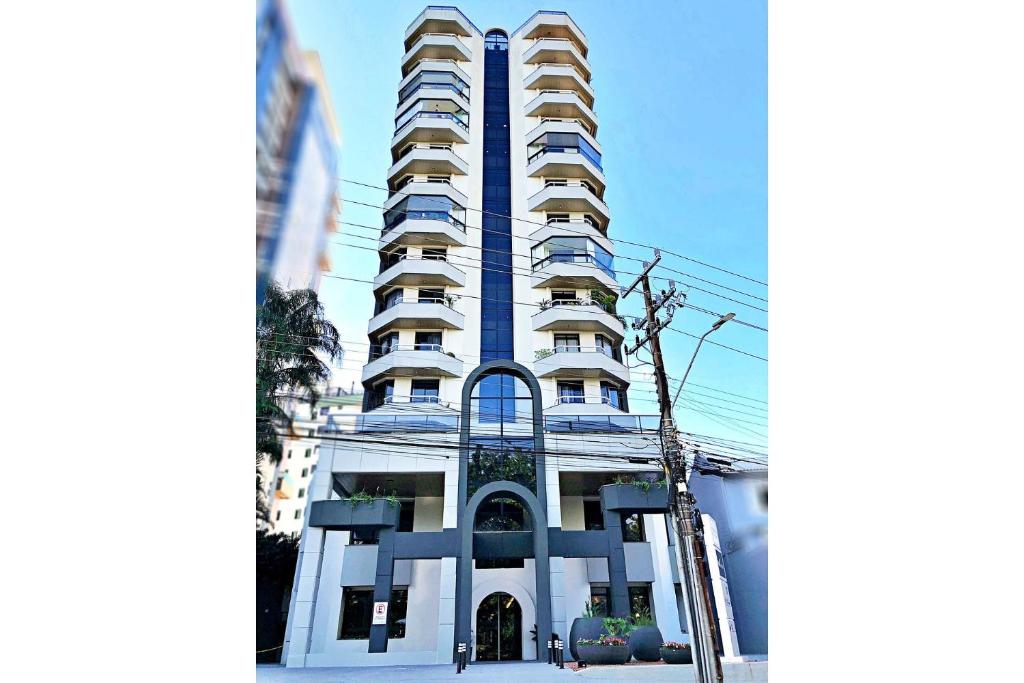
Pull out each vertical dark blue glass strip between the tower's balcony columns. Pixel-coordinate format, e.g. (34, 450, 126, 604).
(480, 31, 514, 364)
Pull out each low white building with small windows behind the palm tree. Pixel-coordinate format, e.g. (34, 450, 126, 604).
(262, 387, 362, 536)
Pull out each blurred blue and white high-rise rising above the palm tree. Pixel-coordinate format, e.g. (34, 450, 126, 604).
(256, 0, 340, 303)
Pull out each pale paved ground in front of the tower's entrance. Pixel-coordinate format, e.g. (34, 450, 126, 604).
(256, 661, 768, 683)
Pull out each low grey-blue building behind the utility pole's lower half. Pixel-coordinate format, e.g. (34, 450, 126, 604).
(689, 456, 768, 655)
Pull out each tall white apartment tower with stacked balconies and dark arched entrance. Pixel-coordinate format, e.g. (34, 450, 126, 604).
(283, 7, 686, 667)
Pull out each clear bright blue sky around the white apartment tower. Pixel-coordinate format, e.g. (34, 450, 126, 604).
(290, 0, 768, 442)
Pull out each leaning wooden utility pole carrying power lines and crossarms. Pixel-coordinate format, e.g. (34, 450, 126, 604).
(623, 249, 722, 683)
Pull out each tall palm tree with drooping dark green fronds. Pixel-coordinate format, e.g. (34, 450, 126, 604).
(256, 283, 342, 514)
